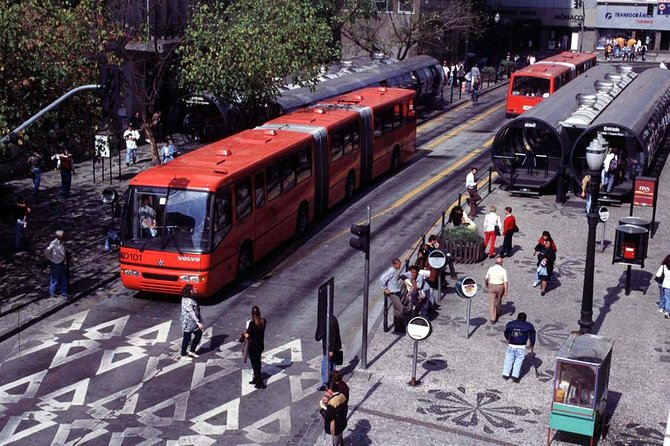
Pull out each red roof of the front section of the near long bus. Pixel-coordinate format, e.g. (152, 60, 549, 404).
(130, 129, 312, 191)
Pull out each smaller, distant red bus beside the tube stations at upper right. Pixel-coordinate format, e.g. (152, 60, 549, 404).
(505, 52, 596, 118)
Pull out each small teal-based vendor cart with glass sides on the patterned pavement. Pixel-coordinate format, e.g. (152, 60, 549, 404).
(547, 333, 614, 446)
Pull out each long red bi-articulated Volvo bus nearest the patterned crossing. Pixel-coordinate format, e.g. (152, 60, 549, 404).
(120, 87, 416, 296)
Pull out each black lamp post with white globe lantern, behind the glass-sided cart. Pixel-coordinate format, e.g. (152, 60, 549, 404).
(578, 138, 606, 333)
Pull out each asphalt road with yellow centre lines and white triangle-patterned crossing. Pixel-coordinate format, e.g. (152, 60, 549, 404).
(0, 89, 505, 445)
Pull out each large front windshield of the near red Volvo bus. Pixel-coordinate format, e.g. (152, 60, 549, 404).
(122, 187, 211, 254)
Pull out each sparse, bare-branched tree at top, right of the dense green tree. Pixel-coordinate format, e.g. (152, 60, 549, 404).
(342, 0, 484, 60)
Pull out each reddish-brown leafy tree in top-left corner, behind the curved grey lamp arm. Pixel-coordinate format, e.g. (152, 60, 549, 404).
(0, 0, 115, 159)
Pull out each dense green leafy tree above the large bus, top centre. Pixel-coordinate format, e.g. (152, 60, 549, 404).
(178, 0, 335, 121)
